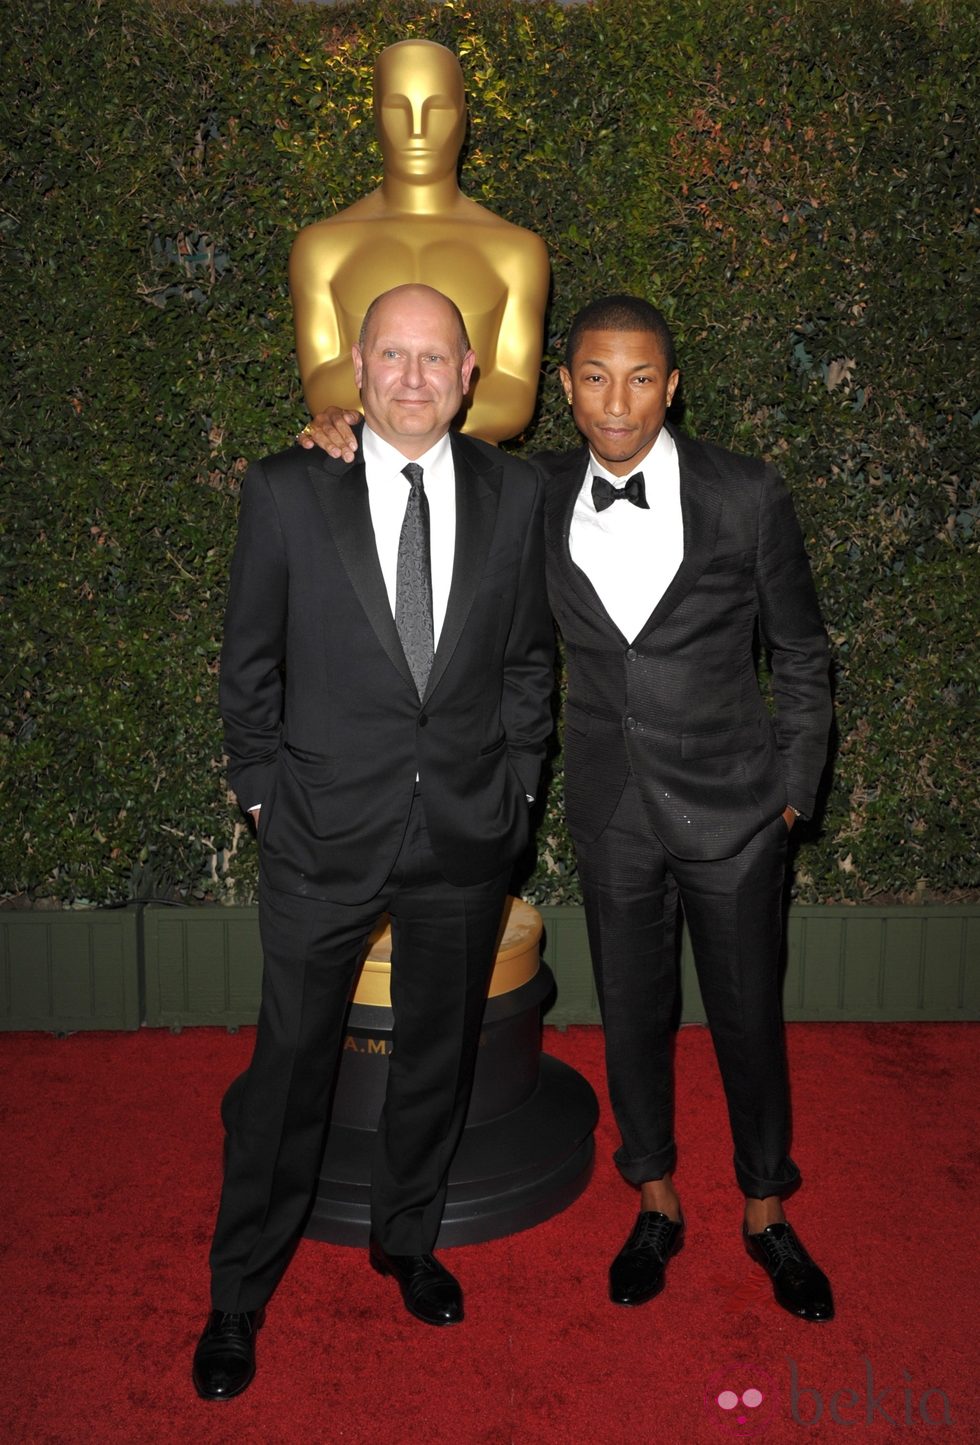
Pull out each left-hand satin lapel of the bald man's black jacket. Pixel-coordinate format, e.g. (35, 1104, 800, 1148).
(309, 452, 415, 688)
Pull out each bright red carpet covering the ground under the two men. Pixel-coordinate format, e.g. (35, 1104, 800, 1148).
(0, 1025, 980, 1445)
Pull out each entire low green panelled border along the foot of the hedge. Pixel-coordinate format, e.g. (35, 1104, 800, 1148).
(0, 903, 980, 1033)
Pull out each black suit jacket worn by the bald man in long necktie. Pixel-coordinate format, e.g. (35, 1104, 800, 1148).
(221, 434, 554, 903)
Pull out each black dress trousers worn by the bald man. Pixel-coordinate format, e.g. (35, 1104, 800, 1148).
(211, 796, 509, 1312)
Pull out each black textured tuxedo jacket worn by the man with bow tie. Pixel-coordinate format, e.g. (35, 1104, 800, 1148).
(536, 428, 831, 860)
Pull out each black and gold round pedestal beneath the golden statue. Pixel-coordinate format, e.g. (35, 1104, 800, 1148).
(306, 899, 598, 1246)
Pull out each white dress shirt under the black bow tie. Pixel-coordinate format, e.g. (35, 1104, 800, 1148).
(568, 428, 684, 642)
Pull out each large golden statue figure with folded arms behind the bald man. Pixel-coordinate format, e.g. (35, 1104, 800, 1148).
(289, 40, 549, 442)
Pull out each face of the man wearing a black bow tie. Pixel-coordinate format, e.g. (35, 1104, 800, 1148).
(561, 331, 681, 477)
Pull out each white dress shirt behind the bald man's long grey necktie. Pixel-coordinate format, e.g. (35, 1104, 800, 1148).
(361, 425, 455, 647)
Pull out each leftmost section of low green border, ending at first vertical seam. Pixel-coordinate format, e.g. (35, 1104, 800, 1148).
(0, 909, 142, 1033)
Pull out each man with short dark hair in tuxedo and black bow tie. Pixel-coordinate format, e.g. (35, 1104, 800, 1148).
(309, 296, 834, 1321)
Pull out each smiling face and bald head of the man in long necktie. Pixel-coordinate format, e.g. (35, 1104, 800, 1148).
(353, 286, 476, 460)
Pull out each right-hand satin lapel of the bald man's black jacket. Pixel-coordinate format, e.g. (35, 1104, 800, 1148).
(425, 432, 500, 698)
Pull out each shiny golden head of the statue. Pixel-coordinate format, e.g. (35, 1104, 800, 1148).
(374, 40, 467, 184)
